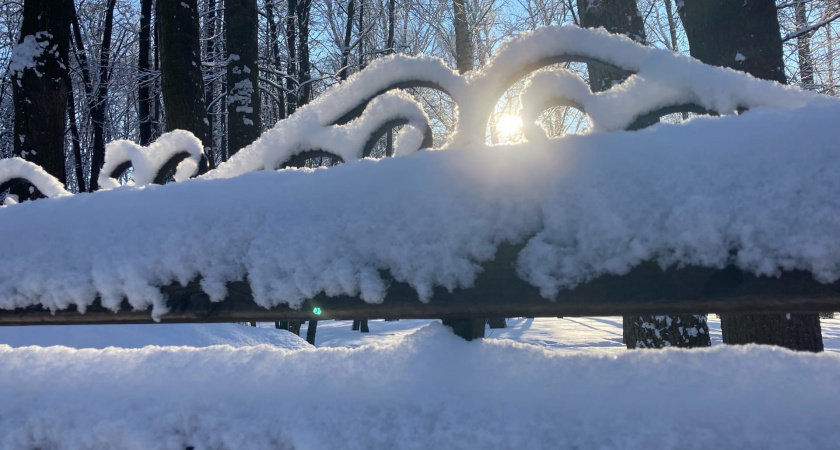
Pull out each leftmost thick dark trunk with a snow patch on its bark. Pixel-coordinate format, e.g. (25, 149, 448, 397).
(10, 0, 71, 201)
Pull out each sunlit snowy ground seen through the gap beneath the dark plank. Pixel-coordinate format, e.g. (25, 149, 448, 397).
(6, 315, 840, 355)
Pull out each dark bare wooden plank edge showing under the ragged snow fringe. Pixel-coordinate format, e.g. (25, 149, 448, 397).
(0, 245, 840, 325)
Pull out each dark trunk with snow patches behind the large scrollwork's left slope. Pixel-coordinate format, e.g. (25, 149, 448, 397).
(225, 0, 262, 156)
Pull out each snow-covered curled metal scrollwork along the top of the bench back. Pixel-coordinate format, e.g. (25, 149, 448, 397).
(0, 27, 827, 192)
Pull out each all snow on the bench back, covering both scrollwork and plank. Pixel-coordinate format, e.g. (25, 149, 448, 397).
(0, 27, 840, 316)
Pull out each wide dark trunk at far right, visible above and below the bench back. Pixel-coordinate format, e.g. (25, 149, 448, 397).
(677, 0, 823, 351)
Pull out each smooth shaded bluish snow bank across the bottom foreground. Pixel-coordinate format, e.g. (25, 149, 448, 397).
(0, 324, 840, 450)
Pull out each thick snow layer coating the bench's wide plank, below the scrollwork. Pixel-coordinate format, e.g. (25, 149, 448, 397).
(0, 103, 840, 314)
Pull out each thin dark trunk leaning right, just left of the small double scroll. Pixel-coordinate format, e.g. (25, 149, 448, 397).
(90, 0, 117, 191)
